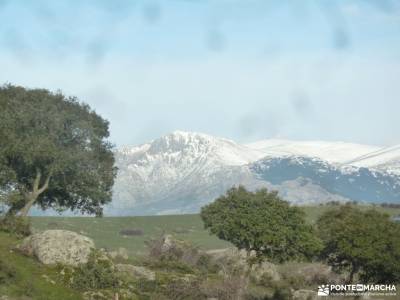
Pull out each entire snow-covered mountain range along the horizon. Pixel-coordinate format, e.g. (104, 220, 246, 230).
(106, 131, 400, 215)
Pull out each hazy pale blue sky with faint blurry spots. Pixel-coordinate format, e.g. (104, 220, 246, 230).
(0, 0, 400, 146)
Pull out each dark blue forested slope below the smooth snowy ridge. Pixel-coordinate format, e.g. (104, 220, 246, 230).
(251, 156, 400, 203)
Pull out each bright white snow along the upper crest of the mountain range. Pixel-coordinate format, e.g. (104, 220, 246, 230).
(119, 130, 400, 169)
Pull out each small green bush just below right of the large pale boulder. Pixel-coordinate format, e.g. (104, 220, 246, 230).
(69, 251, 119, 291)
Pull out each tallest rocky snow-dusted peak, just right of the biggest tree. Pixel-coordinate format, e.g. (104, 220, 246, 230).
(112, 131, 263, 213)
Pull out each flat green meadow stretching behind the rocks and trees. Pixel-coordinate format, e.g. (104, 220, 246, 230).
(32, 205, 400, 257)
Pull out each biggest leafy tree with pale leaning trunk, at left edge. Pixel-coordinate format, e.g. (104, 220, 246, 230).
(0, 85, 116, 216)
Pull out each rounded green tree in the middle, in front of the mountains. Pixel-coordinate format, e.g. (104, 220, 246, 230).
(201, 186, 321, 262)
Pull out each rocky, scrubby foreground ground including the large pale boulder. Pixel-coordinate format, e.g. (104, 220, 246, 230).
(0, 230, 354, 300)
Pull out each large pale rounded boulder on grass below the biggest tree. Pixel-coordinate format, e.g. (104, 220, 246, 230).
(18, 230, 95, 266)
